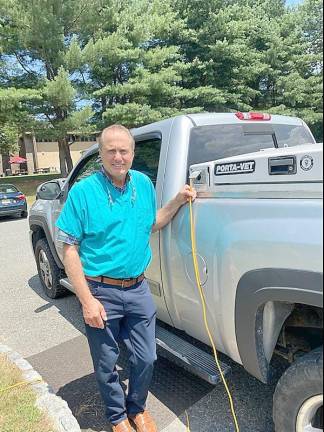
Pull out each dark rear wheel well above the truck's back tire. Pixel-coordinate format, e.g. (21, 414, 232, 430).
(275, 304, 323, 363)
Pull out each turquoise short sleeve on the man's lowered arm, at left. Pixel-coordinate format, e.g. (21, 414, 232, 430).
(56, 185, 84, 243)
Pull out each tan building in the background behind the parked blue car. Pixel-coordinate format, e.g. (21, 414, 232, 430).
(0, 133, 97, 177)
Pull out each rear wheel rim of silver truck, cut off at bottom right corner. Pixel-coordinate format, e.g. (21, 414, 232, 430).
(296, 395, 323, 432)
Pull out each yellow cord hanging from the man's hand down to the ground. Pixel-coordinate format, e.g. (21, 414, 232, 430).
(188, 180, 240, 432)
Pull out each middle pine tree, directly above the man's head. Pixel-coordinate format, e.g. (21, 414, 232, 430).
(82, 0, 201, 127)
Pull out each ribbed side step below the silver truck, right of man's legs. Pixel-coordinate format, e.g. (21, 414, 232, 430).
(156, 325, 231, 385)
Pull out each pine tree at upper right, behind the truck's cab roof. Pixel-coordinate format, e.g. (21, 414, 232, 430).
(170, 0, 323, 139)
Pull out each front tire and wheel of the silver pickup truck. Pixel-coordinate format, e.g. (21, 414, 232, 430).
(35, 238, 67, 299)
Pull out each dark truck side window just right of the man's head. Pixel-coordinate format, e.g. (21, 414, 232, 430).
(132, 138, 162, 186)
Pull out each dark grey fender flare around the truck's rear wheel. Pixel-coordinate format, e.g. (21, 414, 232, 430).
(235, 268, 323, 383)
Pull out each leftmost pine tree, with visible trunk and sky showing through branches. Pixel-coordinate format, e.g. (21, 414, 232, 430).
(0, 0, 94, 176)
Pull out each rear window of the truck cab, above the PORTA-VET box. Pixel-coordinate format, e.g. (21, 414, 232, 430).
(188, 123, 315, 168)
